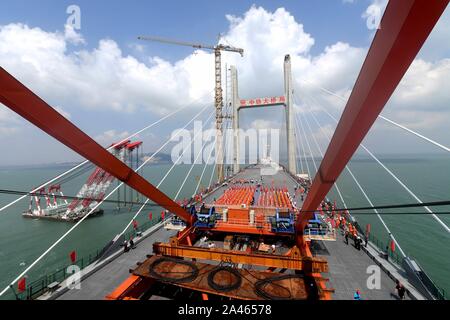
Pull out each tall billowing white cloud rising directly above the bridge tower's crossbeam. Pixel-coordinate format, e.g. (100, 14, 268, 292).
(222, 6, 314, 97)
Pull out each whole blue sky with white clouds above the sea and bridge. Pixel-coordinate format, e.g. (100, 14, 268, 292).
(0, 0, 450, 166)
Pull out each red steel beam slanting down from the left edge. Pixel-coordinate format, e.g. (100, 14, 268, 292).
(0, 67, 194, 225)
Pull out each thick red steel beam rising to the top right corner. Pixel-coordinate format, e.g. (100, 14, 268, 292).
(296, 0, 449, 239)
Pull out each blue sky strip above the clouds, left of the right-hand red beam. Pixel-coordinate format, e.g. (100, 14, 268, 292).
(0, 0, 370, 61)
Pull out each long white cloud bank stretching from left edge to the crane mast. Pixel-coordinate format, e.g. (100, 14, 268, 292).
(0, 24, 213, 114)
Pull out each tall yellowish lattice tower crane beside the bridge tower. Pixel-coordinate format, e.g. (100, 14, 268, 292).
(138, 36, 244, 183)
